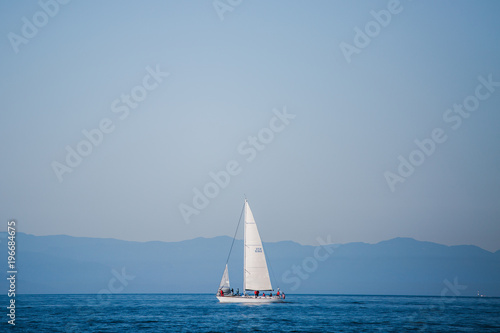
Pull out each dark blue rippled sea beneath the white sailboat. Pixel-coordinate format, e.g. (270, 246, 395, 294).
(0, 294, 500, 332)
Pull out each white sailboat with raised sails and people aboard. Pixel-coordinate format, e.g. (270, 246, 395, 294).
(217, 198, 285, 303)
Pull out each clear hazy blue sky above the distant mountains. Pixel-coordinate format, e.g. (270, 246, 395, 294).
(0, 0, 500, 250)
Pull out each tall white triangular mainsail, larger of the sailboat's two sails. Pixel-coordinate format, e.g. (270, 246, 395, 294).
(243, 199, 273, 291)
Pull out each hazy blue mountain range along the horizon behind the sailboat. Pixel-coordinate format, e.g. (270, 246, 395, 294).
(0, 232, 500, 297)
